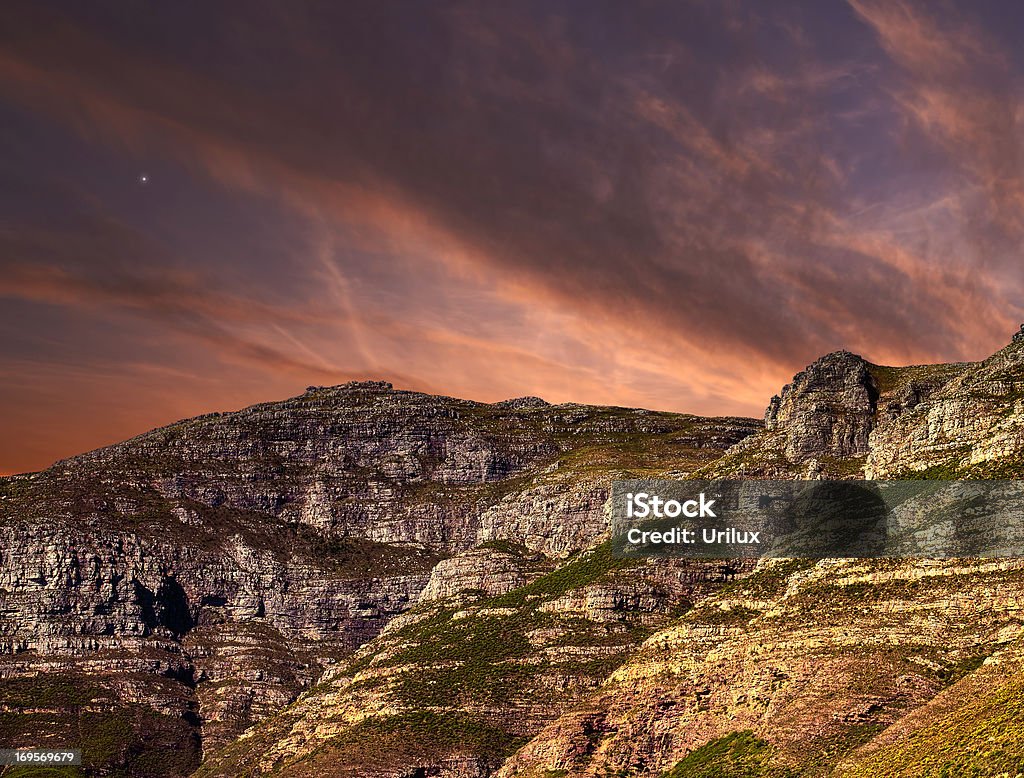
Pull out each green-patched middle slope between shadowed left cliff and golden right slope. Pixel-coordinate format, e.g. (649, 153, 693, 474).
(200, 544, 757, 778)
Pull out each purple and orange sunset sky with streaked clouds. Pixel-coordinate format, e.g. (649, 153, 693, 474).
(0, 0, 1024, 473)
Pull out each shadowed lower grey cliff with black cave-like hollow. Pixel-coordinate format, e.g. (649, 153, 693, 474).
(0, 502, 436, 772)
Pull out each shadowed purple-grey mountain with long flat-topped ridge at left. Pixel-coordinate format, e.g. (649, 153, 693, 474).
(0, 383, 758, 776)
